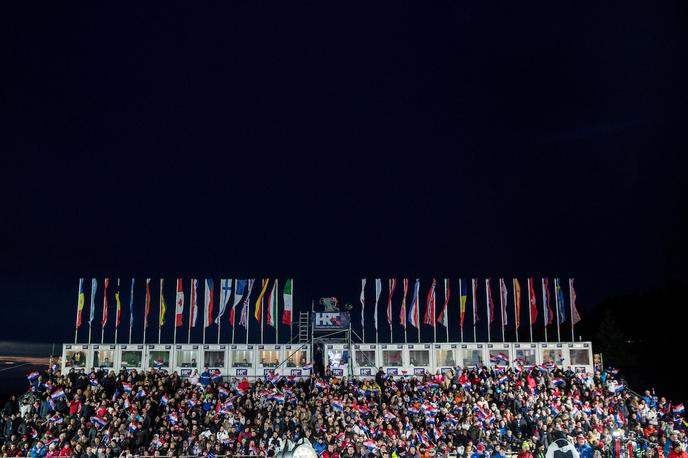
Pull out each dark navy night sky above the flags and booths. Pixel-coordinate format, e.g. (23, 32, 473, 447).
(0, 1, 688, 342)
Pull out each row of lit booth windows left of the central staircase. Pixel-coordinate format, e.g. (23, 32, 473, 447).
(65, 350, 307, 368)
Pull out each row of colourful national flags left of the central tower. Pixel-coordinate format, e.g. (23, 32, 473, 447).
(76, 278, 294, 330)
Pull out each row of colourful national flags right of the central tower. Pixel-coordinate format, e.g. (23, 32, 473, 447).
(360, 278, 581, 340)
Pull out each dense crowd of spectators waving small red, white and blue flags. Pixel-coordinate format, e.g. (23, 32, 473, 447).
(0, 361, 688, 458)
